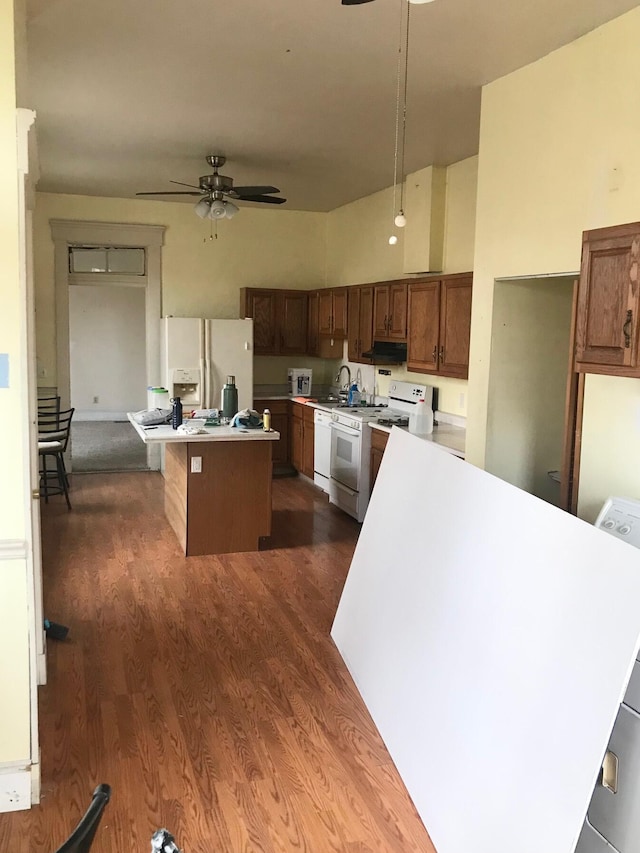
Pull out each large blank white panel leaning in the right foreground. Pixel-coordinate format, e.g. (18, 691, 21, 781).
(332, 430, 640, 853)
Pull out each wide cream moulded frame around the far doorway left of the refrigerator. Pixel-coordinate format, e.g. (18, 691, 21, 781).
(49, 219, 166, 471)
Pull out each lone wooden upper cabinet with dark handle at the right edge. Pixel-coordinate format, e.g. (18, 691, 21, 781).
(576, 222, 640, 377)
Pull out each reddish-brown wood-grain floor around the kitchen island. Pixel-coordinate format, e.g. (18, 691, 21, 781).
(0, 473, 433, 853)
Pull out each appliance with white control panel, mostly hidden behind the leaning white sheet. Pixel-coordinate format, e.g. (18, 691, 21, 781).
(576, 497, 640, 853)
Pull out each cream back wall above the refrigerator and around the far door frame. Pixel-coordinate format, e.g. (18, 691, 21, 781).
(34, 193, 326, 386)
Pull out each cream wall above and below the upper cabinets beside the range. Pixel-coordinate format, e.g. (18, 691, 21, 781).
(327, 157, 478, 416)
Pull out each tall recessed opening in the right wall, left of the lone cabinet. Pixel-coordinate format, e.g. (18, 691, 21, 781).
(485, 275, 575, 506)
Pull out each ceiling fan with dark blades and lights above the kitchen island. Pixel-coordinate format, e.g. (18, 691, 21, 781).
(136, 154, 286, 219)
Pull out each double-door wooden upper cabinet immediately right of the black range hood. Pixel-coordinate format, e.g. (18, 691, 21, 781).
(407, 273, 473, 379)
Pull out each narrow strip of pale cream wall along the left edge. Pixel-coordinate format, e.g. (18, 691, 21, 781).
(0, 0, 30, 765)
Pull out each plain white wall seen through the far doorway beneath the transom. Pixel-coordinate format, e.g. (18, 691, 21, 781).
(69, 284, 147, 420)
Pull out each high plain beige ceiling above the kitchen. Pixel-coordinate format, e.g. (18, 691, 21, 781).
(25, 0, 637, 211)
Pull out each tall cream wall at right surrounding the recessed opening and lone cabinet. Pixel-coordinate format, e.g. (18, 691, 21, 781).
(467, 8, 640, 520)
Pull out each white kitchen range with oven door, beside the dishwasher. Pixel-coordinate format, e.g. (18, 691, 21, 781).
(329, 382, 433, 521)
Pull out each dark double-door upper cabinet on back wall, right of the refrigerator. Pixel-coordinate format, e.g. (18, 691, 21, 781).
(240, 287, 308, 355)
